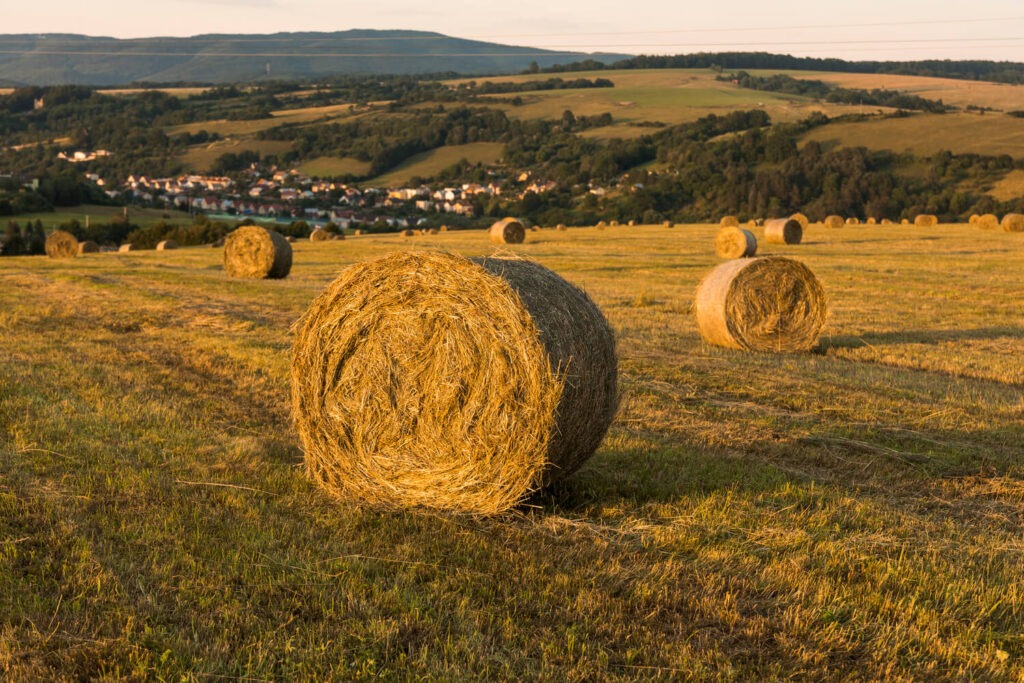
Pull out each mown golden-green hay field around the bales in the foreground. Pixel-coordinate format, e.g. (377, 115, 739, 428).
(0, 225, 1024, 681)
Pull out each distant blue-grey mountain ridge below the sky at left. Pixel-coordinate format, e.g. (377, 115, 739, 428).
(0, 29, 631, 87)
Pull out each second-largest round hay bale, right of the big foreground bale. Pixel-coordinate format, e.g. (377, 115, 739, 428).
(693, 256, 826, 352)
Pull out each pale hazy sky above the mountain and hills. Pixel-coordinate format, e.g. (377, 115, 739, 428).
(6, 0, 1024, 61)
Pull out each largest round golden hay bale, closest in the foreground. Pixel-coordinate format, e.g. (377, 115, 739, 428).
(291, 252, 617, 514)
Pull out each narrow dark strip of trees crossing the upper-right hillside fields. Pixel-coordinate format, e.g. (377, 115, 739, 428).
(718, 71, 950, 114)
